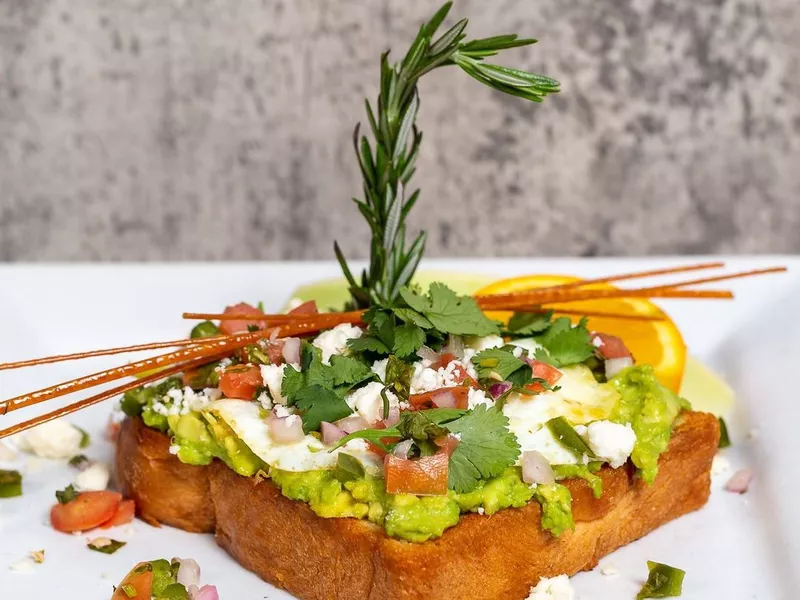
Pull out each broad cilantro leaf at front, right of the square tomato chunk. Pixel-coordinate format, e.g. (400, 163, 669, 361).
(447, 404, 519, 493)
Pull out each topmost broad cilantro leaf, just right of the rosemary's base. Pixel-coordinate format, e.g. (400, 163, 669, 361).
(400, 282, 498, 336)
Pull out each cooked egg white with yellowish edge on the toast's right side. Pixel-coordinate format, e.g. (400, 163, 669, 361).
(503, 365, 619, 465)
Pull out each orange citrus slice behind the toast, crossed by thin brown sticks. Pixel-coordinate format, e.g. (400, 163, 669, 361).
(477, 275, 686, 393)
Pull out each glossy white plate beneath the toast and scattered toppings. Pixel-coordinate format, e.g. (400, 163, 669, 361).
(0, 257, 800, 600)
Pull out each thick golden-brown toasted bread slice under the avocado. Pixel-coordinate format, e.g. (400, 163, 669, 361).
(116, 412, 719, 600)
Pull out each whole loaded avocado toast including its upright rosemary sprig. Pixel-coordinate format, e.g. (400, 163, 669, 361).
(104, 4, 719, 599)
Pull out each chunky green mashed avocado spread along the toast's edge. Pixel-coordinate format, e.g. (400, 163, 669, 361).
(123, 365, 689, 542)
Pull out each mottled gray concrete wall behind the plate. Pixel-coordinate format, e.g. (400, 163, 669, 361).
(0, 0, 800, 261)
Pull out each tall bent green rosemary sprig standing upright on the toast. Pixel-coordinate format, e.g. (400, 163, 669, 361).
(334, 2, 559, 308)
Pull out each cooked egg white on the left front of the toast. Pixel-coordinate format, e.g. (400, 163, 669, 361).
(206, 398, 383, 474)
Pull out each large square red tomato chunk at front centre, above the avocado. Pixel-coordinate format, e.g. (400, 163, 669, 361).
(383, 452, 450, 496)
